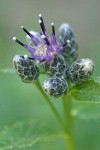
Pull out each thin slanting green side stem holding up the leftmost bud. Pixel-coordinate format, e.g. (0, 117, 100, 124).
(35, 81, 65, 130)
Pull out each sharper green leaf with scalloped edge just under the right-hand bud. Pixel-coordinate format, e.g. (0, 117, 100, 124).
(70, 78, 100, 103)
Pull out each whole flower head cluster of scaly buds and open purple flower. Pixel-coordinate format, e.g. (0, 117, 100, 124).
(13, 14, 94, 97)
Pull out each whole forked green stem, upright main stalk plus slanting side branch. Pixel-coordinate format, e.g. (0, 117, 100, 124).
(35, 81, 75, 150)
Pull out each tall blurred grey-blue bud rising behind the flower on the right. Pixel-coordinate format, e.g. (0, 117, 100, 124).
(58, 23, 78, 64)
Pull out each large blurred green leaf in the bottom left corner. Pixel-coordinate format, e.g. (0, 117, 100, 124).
(0, 120, 63, 150)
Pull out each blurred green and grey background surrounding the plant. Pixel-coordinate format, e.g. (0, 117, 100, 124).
(0, 0, 100, 150)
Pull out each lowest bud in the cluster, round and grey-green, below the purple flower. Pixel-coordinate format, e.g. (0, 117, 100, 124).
(43, 77, 69, 97)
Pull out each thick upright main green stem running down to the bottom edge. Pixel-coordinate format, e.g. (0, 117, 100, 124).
(63, 94, 75, 150)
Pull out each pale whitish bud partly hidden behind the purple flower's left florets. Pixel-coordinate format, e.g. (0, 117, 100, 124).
(26, 30, 42, 47)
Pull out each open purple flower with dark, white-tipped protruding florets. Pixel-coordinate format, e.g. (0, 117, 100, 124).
(13, 14, 63, 63)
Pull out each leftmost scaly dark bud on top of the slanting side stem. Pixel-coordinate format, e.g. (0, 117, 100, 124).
(13, 55, 39, 83)
